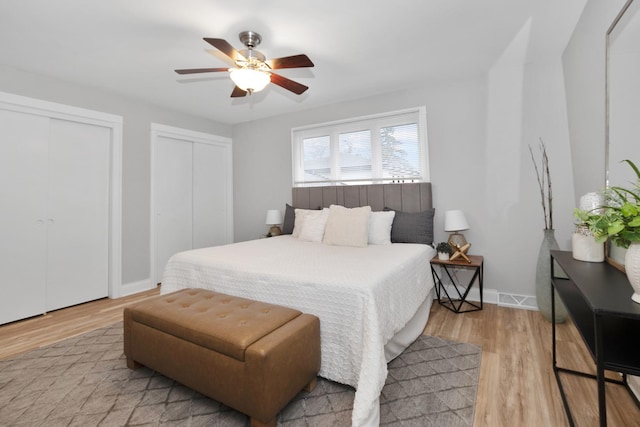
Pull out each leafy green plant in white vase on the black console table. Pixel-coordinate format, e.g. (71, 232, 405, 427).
(575, 160, 640, 303)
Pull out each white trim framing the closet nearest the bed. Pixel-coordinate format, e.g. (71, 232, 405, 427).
(148, 123, 233, 290)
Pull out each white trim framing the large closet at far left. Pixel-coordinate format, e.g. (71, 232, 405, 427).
(0, 92, 122, 298)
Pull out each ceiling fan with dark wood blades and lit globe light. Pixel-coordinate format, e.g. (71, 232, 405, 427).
(175, 31, 313, 98)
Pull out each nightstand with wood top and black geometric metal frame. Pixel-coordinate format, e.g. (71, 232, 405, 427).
(431, 255, 484, 313)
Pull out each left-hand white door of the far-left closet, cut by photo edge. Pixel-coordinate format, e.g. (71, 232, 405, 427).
(0, 110, 49, 324)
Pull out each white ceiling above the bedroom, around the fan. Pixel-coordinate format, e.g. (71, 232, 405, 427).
(0, 0, 586, 124)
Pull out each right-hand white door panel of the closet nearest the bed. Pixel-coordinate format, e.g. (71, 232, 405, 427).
(193, 143, 231, 249)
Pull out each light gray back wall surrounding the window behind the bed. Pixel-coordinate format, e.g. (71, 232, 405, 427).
(233, 57, 573, 295)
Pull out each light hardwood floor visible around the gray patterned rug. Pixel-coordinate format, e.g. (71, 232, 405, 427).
(0, 289, 640, 427)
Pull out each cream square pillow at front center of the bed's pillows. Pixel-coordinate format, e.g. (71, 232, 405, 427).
(322, 205, 371, 246)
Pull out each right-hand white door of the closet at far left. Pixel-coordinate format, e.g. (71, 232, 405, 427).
(47, 119, 111, 310)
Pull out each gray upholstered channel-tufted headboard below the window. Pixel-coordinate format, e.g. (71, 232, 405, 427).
(291, 182, 433, 213)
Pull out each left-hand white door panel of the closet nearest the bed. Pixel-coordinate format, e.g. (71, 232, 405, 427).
(153, 136, 193, 281)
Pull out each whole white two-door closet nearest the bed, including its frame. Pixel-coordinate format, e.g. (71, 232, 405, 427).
(151, 123, 233, 283)
